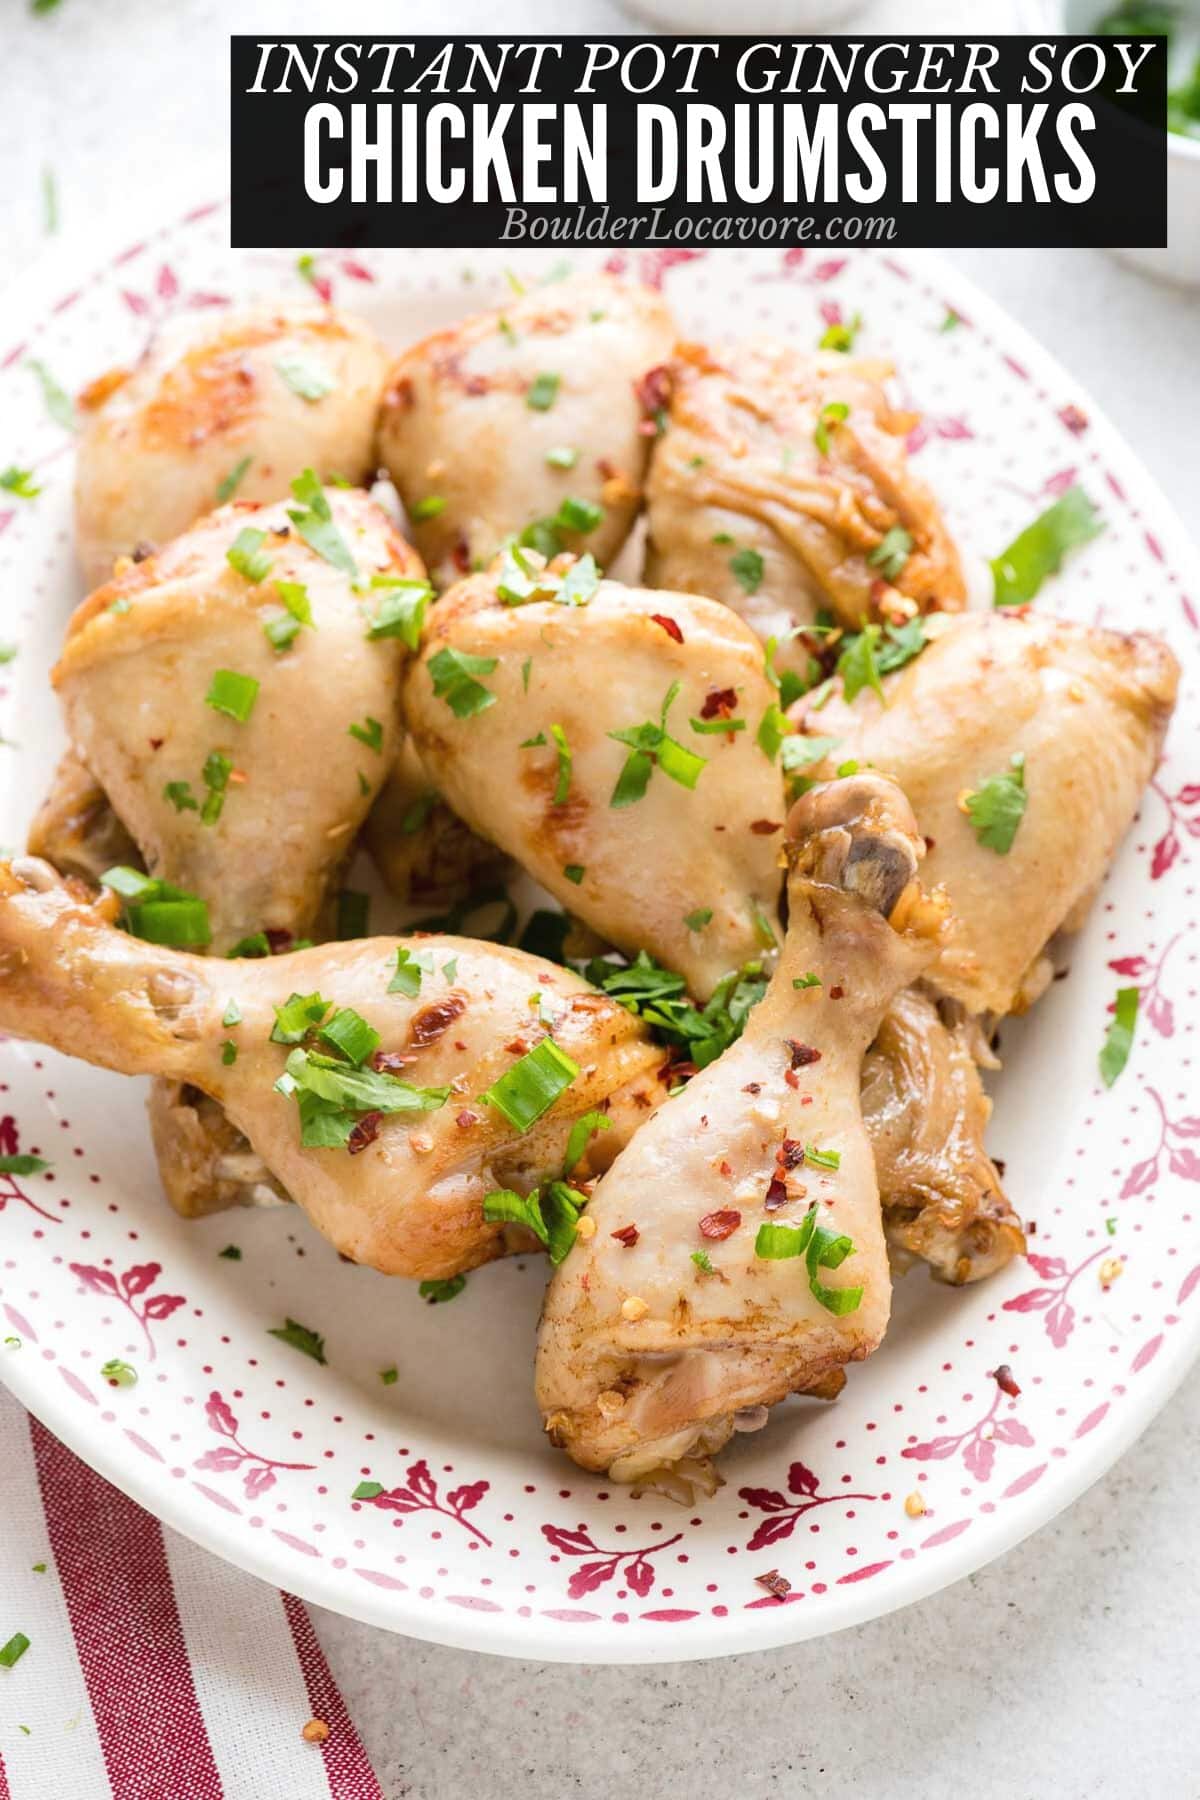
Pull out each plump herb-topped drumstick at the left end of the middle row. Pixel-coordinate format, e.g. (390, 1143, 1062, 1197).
(54, 490, 423, 952)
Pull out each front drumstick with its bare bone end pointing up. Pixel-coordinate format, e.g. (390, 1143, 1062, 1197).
(536, 776, 939, 1481)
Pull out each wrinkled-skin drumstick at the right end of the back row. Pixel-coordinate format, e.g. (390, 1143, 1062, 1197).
(646, 340, 966, 668)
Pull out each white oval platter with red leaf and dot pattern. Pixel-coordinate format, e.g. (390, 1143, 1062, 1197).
(0, 205, 1200, 1661)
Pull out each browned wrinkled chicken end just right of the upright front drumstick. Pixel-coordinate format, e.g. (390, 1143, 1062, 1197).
(862, 986, 1025, 1287)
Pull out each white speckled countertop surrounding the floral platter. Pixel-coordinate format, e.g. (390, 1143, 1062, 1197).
(0, 0, 1200, 1800)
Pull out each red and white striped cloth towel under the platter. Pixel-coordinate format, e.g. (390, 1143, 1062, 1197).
(0, 1390, 385, 1800)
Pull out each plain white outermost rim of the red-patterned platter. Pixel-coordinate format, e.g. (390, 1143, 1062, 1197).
(0, 194, 1200, 1665)
